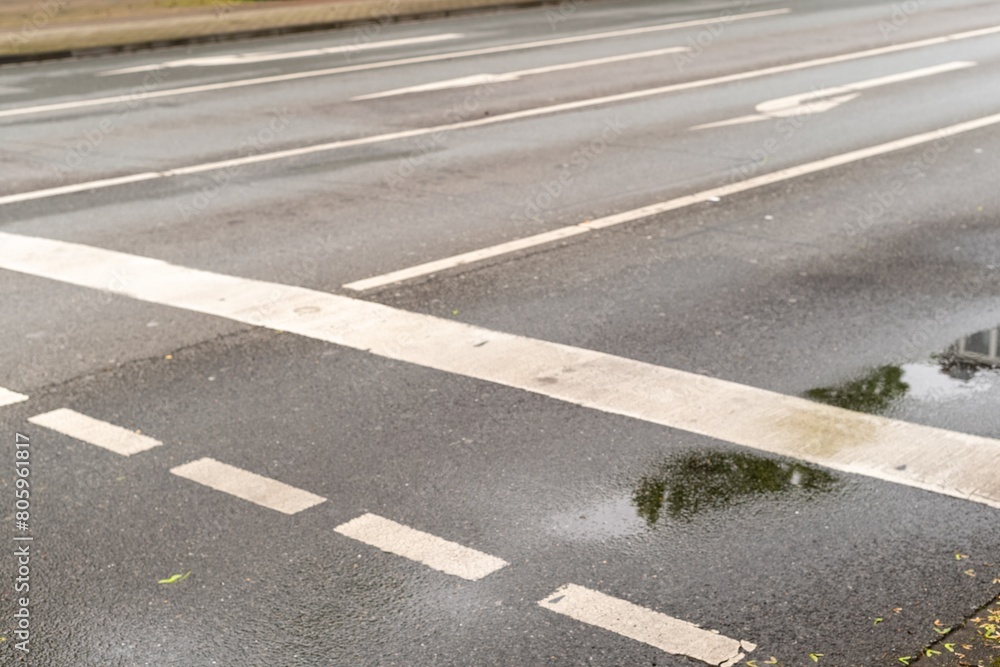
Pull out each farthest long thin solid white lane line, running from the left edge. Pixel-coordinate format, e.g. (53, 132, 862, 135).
(0, 9, 792, 118)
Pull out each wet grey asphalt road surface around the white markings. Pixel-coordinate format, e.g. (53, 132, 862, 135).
(0, 0, 1000, 667)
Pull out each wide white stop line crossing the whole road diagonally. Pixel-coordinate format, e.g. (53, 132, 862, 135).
(0, 232, 1000, 508)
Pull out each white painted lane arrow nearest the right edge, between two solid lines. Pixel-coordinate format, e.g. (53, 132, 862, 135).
(690, 60, 977, 130)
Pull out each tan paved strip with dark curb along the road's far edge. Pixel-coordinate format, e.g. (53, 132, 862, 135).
(0, 0, 560, 64)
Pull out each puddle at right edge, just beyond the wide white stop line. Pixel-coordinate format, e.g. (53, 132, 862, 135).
(805, 327, 1000, 435)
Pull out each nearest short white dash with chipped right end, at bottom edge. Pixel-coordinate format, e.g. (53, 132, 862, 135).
(538, 584, 757, 667)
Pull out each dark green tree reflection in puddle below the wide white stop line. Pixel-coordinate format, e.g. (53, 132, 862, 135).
(632, 452, 836, 526)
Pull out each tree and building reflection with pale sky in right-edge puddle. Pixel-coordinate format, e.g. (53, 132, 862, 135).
(806, 327, 1000, 418)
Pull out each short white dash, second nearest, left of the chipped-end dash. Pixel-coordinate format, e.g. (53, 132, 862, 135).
(334, 514, 507, 581)
